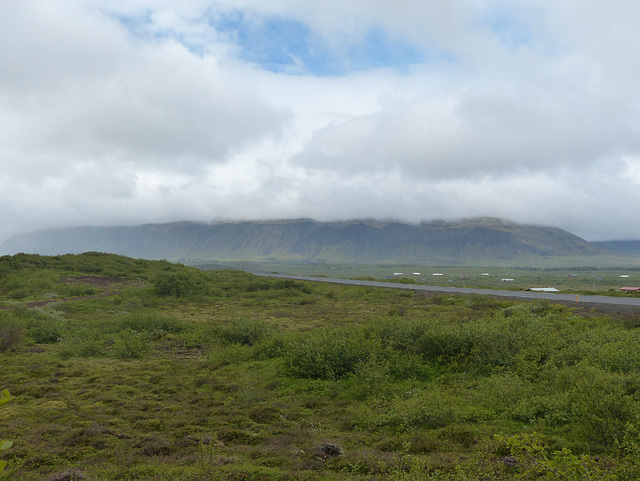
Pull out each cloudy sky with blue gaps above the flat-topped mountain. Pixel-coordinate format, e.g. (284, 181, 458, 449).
(0, 0, 640, 242)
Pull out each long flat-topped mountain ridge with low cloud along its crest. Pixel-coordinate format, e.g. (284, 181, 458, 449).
(0, 218, 605, 265)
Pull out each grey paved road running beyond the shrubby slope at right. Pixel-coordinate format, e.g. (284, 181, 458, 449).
(257, 274, 640, 307)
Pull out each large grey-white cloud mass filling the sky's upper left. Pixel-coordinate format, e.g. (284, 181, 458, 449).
(0, 2, 288, 175)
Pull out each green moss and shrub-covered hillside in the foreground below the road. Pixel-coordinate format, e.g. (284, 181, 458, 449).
(0, 253, 640, 481)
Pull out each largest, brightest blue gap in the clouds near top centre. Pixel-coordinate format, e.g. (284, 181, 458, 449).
(210, 12, 446, 76)
